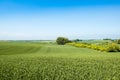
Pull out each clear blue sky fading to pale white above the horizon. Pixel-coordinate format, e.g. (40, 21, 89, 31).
(0, 0, 120, 40)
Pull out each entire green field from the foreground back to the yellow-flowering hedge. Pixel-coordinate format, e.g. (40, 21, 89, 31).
(0, 42, 120, 80)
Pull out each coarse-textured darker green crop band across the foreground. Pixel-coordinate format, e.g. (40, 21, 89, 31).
(0, 57, 120, 80)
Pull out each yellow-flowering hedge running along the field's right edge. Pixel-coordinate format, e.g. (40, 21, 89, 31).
(67, 42, 120, 52)
